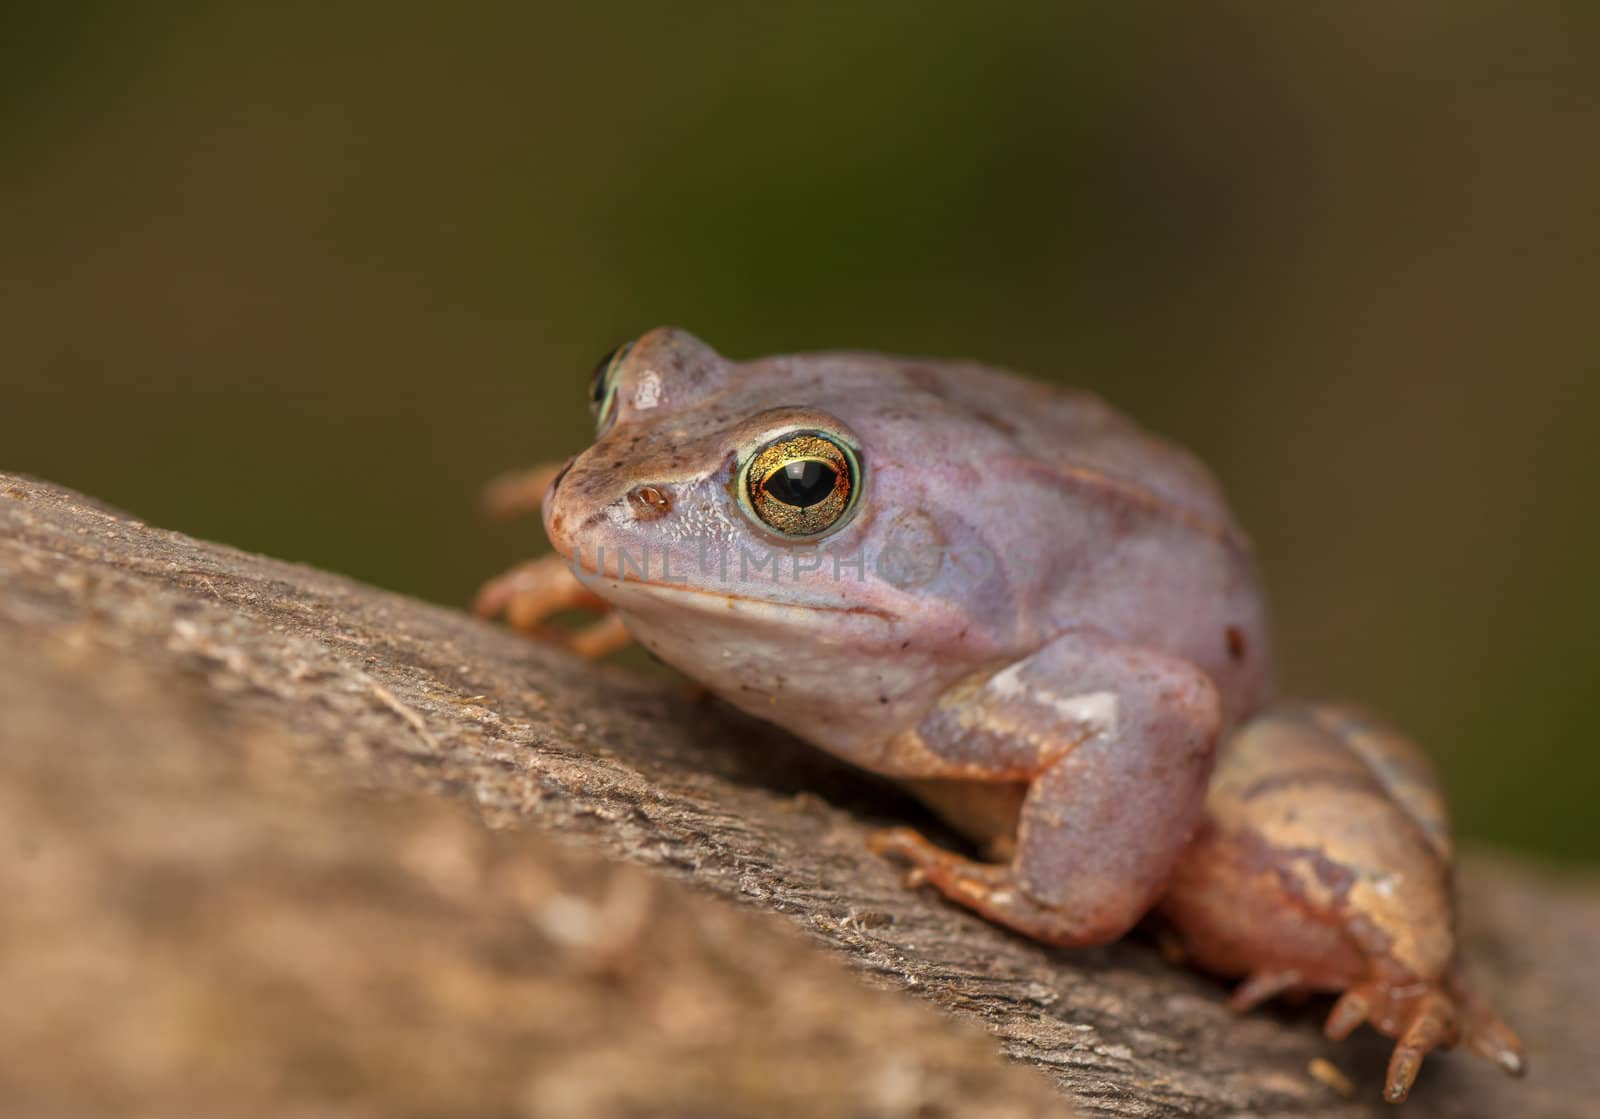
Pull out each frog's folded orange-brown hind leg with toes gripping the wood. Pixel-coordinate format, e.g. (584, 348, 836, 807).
(1162, 706, 1523, 1101)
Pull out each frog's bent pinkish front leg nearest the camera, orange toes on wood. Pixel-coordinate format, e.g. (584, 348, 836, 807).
(874, 631, 1222, 945)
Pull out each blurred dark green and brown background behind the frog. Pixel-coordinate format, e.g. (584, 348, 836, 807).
(0, 2, 1600, 860)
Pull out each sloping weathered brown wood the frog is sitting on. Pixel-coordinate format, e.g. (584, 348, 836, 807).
(0, 475, 1600, 1116)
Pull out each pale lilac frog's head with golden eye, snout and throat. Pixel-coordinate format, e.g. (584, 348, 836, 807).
(544, 328, 1004, 752)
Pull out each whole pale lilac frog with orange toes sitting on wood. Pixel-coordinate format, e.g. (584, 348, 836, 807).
(475, 327, 1523, 1098)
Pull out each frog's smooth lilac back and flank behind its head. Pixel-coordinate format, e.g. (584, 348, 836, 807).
(796, 354, 1270, 717)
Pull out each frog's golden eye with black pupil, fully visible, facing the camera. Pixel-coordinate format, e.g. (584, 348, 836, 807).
(739, 431, 861, 536)
